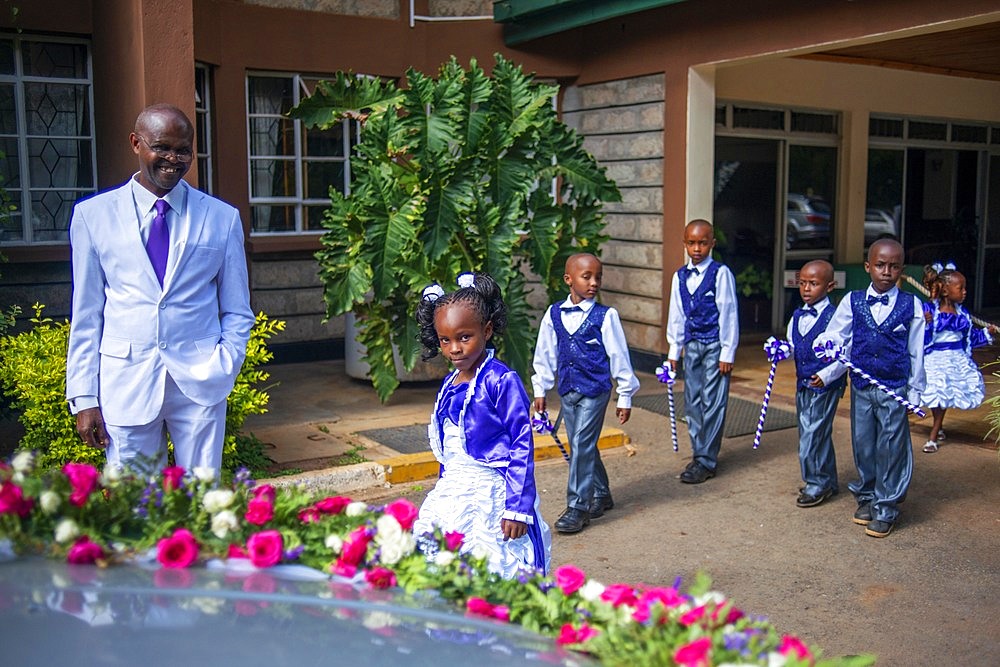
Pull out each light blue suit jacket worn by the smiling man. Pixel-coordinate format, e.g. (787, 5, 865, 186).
(66, 181, 254, 426)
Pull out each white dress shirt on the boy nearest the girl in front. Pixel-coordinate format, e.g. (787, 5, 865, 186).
(531, 297, 639, 409)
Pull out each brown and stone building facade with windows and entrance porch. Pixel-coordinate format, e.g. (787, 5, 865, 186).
(0, 0, 1000, 360)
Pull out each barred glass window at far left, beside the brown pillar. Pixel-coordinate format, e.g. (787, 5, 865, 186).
(0, 35, 96, 245)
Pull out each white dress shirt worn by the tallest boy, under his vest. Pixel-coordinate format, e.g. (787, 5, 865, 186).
(667, 257, 740, 364)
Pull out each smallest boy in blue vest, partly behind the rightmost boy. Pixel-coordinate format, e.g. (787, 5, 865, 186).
(786, 259, 847, 507)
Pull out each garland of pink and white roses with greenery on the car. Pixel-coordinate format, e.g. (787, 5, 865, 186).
(0, 452, 873, 667)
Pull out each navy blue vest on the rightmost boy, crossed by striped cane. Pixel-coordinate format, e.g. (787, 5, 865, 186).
(850, 290, 915, 389)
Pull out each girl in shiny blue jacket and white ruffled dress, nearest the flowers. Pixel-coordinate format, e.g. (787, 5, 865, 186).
(413, 273, 552, 578)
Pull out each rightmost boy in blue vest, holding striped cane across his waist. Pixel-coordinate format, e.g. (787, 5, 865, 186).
(817, 239, 926, 537)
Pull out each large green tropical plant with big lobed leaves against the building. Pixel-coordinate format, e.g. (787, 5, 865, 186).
(291, 55, 620, 401)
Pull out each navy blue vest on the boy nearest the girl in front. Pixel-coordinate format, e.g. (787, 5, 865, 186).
(549, 302, 611, 396)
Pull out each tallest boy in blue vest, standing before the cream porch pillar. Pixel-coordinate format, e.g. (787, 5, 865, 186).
(667, 220, 739, 484)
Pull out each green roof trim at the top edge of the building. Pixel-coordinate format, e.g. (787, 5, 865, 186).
(493, 0, 686, 46)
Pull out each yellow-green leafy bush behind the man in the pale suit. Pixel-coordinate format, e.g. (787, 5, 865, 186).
(0, 303, 285, 470)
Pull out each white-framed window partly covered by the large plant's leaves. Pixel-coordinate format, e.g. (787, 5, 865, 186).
(247, 73, 357, 234)
